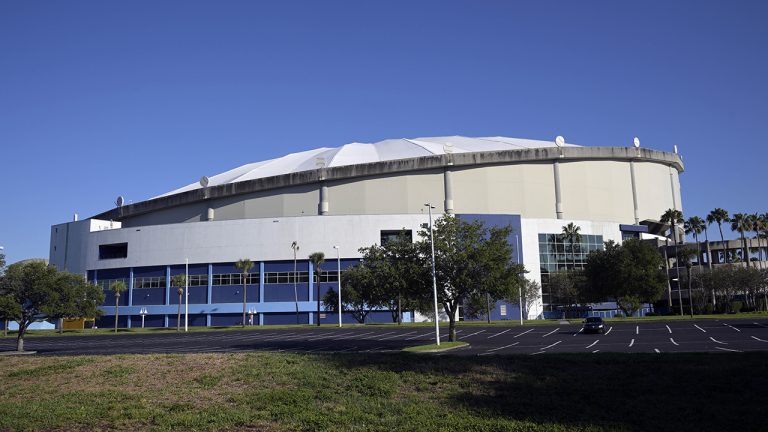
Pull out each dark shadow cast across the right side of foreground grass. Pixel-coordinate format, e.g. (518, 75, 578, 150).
(314, 353, 768, 432)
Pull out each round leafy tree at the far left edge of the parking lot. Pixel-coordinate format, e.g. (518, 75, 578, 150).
(0, 261, 104, 351)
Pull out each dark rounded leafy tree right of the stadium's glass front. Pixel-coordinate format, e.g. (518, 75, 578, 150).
(584, 239, 667, 316)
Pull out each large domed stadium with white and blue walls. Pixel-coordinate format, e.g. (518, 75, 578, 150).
(50, 136, 683, 327)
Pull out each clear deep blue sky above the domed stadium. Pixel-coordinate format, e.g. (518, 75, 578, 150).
(0, 0, 768, 262)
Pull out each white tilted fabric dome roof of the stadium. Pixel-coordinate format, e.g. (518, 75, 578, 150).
(157, 136, 579, 198)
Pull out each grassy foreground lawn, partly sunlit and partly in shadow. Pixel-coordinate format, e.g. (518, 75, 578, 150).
(0, 353, 768, 432)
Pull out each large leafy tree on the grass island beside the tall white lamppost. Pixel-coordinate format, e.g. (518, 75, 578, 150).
(417, 215, 522, 341)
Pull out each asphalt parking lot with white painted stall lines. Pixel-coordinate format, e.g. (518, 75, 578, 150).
(0, 319, 768, 356)
